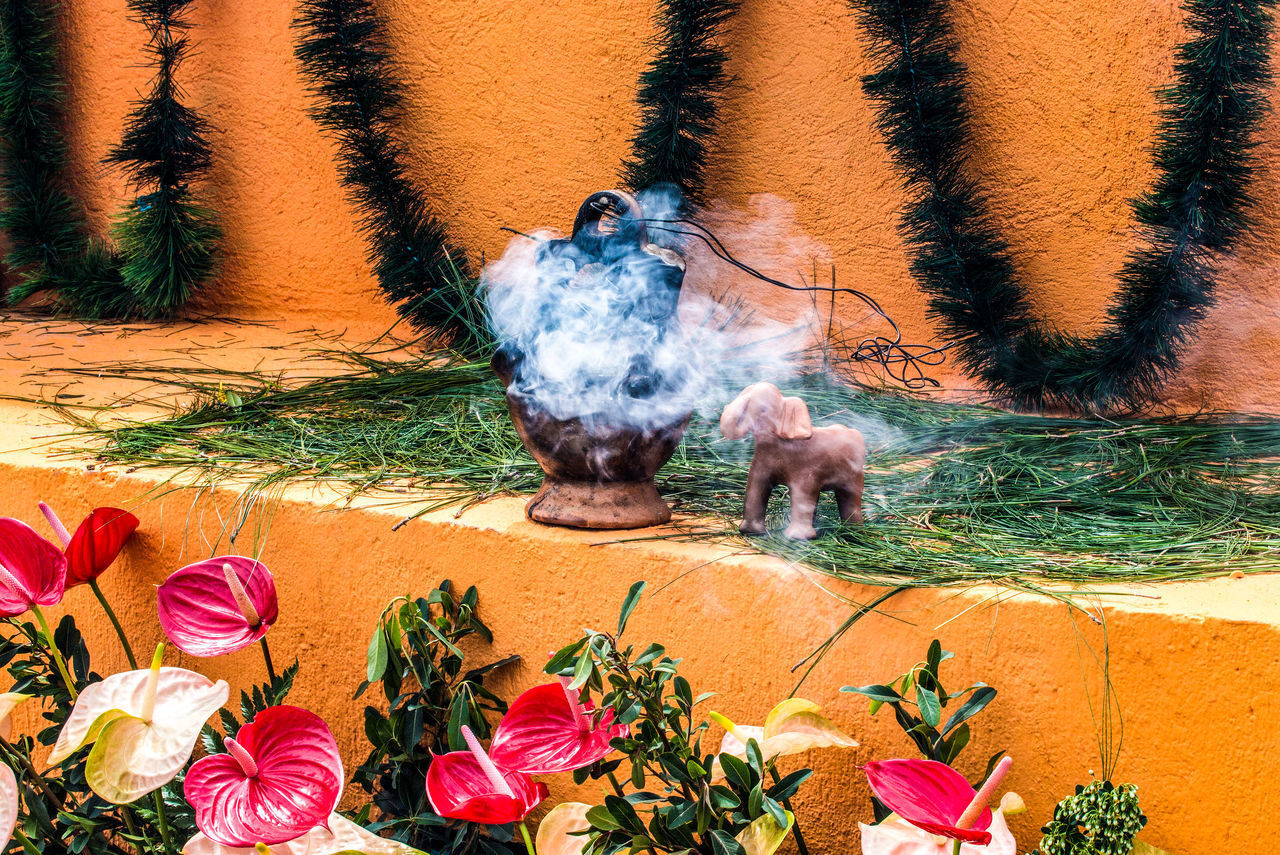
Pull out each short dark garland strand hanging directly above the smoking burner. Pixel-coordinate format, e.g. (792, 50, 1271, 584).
(622, 0, 739, 202)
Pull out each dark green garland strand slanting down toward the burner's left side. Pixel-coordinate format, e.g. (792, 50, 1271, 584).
(294, 0, 481, 349)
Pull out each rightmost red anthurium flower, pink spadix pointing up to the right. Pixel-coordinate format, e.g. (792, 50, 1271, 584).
(865, 756, 1012, 846)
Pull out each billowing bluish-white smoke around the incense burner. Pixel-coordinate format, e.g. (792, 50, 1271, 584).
(483, 189, 849, 429)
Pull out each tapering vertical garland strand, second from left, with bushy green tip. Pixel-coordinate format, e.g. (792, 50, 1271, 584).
(108, 0, 221, 317)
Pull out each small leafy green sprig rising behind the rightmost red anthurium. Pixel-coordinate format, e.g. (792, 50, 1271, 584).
(840, 639, 1005, 785)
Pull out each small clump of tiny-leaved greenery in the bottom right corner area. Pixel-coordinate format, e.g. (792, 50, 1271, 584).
(1037, 781, 1147, 855)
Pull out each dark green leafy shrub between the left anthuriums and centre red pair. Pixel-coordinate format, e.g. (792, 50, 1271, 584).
(352, 581, 524, 855)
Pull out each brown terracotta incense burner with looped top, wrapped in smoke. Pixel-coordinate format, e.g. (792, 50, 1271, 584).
(492, 191, 690, 529)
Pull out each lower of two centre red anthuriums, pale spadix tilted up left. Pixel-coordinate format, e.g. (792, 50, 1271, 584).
(426, 724, 548, 826)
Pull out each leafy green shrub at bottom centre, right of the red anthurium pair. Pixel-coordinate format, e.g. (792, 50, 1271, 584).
(545, 582, 812, 855)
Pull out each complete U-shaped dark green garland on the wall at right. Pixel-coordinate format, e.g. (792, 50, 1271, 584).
(850, 0, 1275, 410)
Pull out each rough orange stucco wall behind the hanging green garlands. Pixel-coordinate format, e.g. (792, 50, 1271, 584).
(47, 0, 1280, 408)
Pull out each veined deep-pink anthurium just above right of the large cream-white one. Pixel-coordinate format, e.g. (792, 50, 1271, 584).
(157, 555, 278, 657)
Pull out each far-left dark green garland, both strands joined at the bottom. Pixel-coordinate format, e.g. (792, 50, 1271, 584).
(0, 0, 219, 317)
